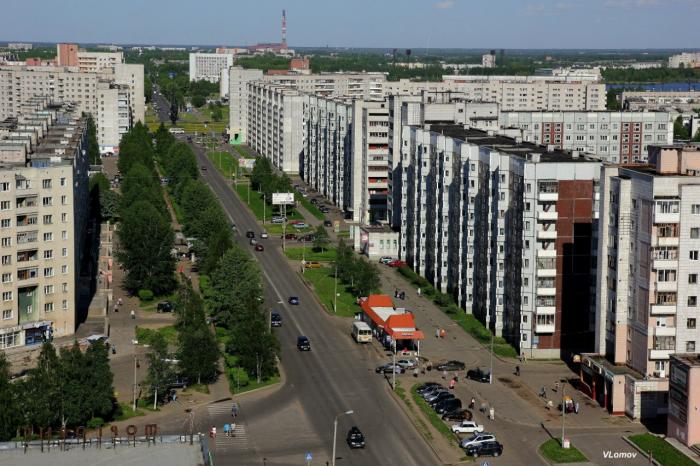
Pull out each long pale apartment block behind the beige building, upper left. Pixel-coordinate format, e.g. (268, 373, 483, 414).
(0, 64, 146, 152)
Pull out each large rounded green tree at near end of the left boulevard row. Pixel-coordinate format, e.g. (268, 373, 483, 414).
(117, 201, 175, 295)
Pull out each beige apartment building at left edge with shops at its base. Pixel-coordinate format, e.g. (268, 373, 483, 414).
(0, 107, 89, 350)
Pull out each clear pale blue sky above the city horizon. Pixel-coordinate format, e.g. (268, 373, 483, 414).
(0, 0, 700, 49)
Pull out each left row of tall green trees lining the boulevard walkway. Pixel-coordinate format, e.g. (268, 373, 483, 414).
(117, 122, 176, 295)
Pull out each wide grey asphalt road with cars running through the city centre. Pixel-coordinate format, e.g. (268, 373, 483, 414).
(193, 146, 438, 466)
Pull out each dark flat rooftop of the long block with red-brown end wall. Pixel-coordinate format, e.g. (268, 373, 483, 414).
(430, 124, 600, 163)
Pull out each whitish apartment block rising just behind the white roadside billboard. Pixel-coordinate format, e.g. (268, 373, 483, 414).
(247, 81, 304, 174)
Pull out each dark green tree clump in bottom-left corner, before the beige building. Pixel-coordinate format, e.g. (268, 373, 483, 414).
(0, 343, 116, 441)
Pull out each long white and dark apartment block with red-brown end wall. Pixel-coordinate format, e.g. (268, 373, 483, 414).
(400, 125, 601, 358)
